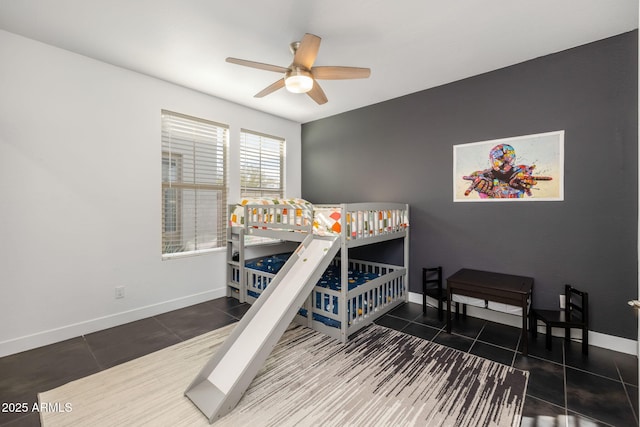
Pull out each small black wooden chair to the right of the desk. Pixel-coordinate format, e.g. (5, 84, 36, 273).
(531, 285, 589, 354)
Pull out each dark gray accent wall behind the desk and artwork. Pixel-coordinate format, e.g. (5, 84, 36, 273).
(302, 31, 638, 340)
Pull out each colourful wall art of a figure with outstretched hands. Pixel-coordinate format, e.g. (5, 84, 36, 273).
(453, 131, 564, 202)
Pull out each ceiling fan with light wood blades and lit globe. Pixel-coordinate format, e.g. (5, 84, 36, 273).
(227, 33, 371, 105)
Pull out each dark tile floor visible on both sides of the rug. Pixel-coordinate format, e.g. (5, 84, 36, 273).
(0, 298, 638, 427)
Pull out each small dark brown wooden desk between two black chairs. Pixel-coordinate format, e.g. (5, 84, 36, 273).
(447, 268, 533, 356)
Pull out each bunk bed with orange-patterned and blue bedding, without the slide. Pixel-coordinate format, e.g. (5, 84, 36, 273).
(227, 199, 409, 342)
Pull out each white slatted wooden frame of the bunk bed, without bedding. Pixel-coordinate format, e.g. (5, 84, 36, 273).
(227, 203, 409, 342)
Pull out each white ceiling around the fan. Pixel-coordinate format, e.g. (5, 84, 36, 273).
(0, 0, 638, 123)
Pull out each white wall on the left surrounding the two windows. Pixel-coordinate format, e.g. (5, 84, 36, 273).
(0, 31, 300, 356)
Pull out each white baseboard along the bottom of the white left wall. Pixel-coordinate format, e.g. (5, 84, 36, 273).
(0, 288, 226, 357)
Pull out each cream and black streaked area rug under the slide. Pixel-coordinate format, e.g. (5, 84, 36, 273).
(38, 325, 528, 427)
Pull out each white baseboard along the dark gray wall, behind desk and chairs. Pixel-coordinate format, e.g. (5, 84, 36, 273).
(409, 292, 638, 356)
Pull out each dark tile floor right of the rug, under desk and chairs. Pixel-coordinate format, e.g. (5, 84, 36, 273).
(376, 303, 638, 427)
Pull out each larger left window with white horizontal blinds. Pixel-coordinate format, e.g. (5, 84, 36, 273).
(162, 110, 229, 256)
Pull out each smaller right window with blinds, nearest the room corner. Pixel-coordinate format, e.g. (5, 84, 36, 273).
(240, 129, 284, 197)
